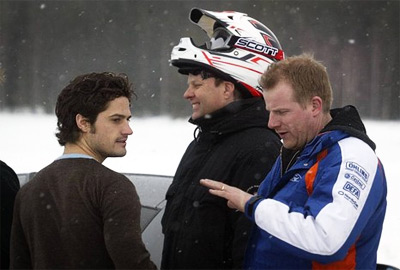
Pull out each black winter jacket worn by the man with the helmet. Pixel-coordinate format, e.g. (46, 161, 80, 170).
(161, 98, 281, 269)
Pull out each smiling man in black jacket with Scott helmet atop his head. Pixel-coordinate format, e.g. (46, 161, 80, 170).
(161, 8, 284, 269)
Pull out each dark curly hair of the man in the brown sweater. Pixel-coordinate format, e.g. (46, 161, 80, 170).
(55, 72, 136, 146)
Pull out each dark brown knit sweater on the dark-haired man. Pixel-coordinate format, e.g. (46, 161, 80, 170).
(11, 158, 156, 269)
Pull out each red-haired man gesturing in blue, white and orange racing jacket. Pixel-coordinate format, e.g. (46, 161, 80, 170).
(201, 55, 387, 269)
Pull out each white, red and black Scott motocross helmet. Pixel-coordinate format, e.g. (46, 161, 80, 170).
(171, 8, 284, 97)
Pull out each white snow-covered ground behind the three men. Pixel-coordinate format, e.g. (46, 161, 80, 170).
(0, 113, 400, 268)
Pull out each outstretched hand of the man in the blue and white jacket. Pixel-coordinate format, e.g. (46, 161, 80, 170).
(200, 179, 252, 212)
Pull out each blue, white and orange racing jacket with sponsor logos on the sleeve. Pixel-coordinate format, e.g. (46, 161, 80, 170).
(244, 106, 387, 269)
